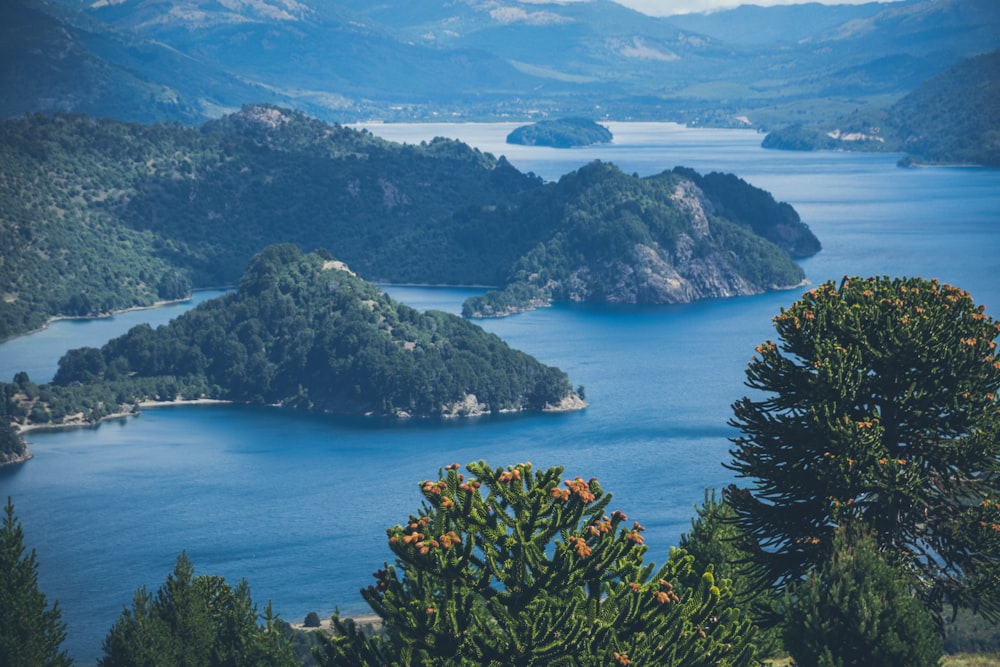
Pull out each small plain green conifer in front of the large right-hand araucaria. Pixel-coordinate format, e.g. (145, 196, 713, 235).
(784, 528, 944, 667)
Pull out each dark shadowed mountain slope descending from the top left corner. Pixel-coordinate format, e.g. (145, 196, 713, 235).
(0, 0, 289, 123)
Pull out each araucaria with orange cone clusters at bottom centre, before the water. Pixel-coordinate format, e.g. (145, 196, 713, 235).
(317, 462, 757, 667)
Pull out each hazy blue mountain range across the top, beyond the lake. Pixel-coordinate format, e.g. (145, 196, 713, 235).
(0, 0, 1000, 129)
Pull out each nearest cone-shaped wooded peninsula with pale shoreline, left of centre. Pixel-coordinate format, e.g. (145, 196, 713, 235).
(5, 244, 584, 424)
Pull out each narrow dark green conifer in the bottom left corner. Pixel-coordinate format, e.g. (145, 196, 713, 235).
(0, 496, 73, 667)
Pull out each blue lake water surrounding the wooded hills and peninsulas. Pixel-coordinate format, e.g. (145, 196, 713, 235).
(0, 123, 1000, 664)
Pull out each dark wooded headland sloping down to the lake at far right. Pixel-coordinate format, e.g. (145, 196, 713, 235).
(763, 51, 1000, 166)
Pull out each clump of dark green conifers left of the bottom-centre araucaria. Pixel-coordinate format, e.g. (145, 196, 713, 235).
(98, 553, 298, 667)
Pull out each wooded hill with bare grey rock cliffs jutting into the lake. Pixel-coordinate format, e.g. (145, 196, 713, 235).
(463, 162, 820, 317)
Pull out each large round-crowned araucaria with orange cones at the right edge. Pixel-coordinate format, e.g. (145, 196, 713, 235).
(727, 277, 1000, 619)
